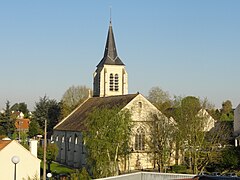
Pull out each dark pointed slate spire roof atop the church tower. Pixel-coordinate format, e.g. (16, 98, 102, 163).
(97, 21, 124, 67)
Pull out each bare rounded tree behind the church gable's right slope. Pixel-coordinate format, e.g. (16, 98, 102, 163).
(147, 87, 171, 111)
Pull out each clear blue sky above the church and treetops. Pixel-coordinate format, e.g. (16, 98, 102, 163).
(0, 0, 240, 109)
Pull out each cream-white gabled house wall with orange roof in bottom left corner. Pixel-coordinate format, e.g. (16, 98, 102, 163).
(0, 140, 41, 180)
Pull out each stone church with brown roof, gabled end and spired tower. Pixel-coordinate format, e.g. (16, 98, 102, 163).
(52, 21, 173, 171)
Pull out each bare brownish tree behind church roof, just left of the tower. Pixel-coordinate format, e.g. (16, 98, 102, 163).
(61, 85, 91, 117)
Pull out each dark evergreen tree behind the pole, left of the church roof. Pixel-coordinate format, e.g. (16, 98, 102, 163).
(32, 96, 61, 132)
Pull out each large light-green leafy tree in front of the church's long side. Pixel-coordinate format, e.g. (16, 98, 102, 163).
(85, 108, 131, 178)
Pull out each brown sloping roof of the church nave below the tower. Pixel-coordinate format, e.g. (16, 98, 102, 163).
(54, 94, 138, 131)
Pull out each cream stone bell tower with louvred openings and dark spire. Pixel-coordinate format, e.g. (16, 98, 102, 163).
(93, 20, 128, 97)
